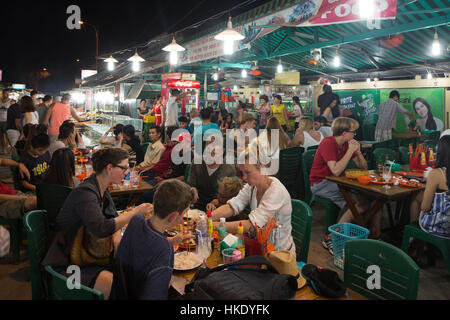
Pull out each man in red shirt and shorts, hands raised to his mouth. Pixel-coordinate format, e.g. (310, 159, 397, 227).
(309, 117, 382, 254)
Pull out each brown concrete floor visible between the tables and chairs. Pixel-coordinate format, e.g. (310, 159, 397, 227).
(0, 153, 450, 300)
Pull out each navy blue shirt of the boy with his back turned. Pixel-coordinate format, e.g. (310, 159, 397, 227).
(110, 215, 174, 300)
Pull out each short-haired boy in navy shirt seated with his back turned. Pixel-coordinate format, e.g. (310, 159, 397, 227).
(110, 180, 194, 300)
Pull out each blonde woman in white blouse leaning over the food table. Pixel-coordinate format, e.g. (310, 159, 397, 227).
(212, 149, 295, 257)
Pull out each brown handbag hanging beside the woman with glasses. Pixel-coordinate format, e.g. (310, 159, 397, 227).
(70, 226, 113, 267)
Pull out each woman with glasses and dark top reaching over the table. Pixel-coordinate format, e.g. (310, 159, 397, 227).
(42, 148, 153, 300)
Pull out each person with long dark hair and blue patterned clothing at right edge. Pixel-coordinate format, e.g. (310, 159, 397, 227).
(410, 136, 450, 239)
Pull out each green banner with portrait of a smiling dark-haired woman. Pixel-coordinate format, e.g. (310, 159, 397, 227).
(380, 88, 444, 133)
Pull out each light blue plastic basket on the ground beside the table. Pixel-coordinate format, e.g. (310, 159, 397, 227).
(328, 223, 370, 270)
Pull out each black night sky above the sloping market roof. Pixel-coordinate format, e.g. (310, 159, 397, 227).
(0, 0, 269, 94)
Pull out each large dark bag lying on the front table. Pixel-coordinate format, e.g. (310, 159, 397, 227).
(181, 256, 297, 300)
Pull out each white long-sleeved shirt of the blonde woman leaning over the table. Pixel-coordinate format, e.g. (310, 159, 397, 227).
(228, 177, 296, 257)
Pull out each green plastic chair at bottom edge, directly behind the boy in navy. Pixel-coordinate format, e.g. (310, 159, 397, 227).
(45, 266, 105, 301)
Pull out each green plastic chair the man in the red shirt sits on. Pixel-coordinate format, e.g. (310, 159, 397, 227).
(302, 150, 341, 233)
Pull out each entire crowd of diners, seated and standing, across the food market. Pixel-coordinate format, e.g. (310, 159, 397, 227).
(0, 88, 450, 299)
